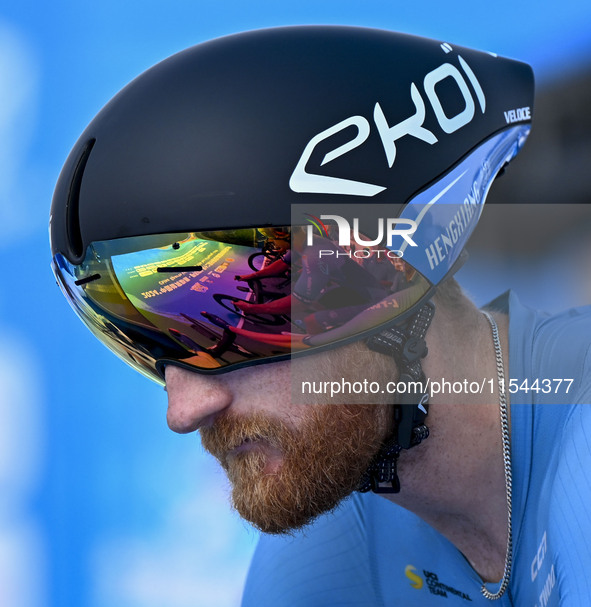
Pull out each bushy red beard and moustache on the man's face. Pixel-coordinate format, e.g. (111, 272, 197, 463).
(200, 405, 390, 533)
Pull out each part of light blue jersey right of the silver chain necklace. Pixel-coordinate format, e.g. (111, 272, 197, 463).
(500, 295, 591, 607)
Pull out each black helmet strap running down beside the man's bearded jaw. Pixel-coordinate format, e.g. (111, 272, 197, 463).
(357, 301, 435, 493)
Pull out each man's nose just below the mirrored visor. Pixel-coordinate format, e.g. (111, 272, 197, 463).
(165, 365, 233, 434)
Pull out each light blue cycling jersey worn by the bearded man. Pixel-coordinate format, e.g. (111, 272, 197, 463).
(243, 294, 591, 607)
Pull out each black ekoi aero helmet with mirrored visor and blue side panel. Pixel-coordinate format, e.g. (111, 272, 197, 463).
(50, 26, 533, 381)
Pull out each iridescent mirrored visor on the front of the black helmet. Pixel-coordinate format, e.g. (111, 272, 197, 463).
(53, 227, 430, 383)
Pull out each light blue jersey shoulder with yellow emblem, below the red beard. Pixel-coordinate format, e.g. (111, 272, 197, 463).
(242, 493, 492, 607)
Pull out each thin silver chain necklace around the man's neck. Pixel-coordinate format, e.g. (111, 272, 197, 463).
(480, 312, 513, 601)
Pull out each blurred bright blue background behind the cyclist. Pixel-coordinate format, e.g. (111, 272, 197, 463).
(0, 0, 591, 607)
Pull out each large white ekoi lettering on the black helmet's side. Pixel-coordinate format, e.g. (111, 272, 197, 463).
(289, 55, 486, 197)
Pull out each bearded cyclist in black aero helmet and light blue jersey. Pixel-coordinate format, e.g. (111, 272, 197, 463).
(51, 27, 591, 607)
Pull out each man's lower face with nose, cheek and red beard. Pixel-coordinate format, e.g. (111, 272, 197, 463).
(166, 346, 392, 533)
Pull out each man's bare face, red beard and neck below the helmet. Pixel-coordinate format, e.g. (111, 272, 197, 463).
(166, 281, 507, 581)
